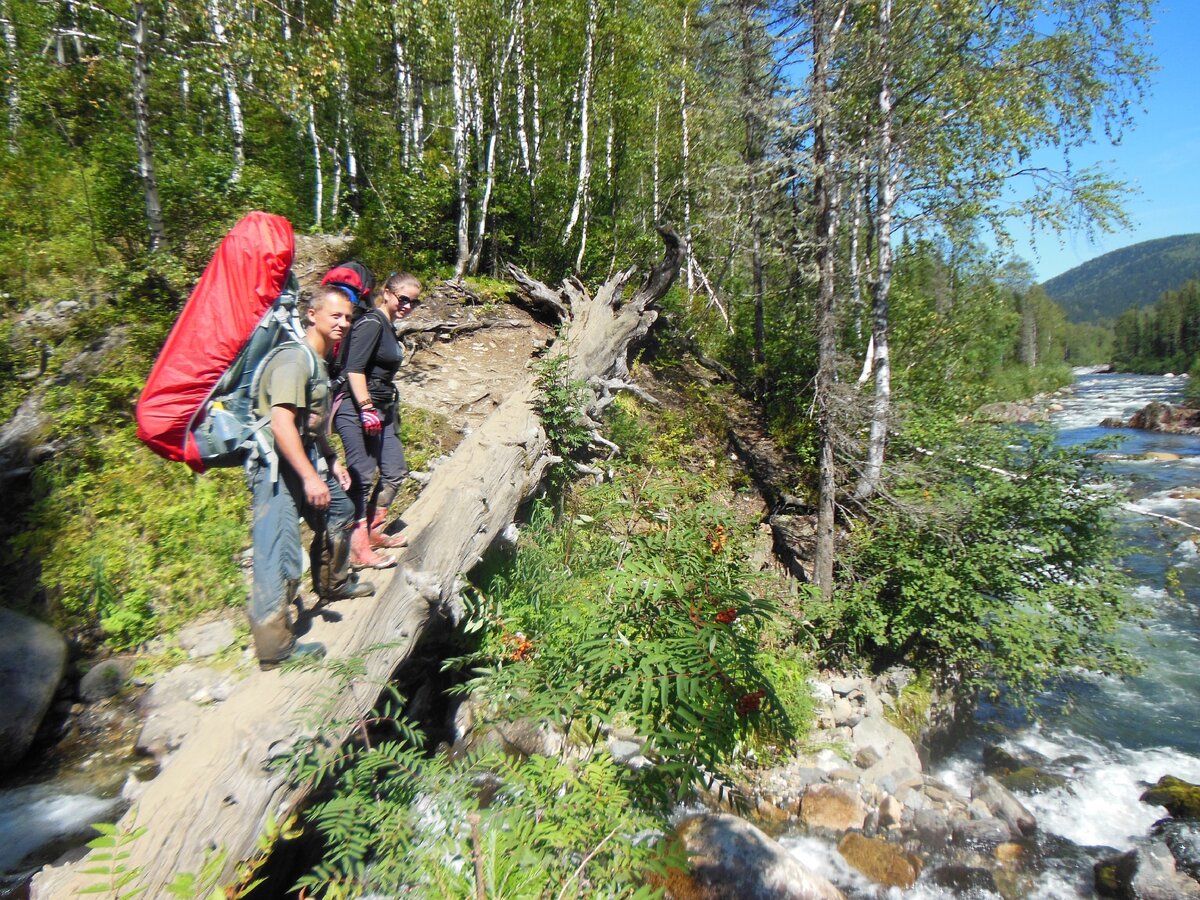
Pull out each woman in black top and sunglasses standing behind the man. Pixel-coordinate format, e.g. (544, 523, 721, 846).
(334, 272, 421, 569)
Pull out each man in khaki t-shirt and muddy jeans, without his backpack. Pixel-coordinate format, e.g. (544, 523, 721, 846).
(246, 286, 374, 668)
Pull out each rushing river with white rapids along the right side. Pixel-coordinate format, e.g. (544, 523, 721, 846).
(787, 374, 1200, 900)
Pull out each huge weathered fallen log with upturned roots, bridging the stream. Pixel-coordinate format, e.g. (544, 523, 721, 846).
(31, 228, 683, 900)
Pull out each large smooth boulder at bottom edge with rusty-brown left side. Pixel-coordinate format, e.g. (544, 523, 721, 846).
(667, 814, 845, 900)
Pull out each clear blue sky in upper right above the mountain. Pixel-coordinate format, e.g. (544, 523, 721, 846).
(1014, 0, 1200, 281)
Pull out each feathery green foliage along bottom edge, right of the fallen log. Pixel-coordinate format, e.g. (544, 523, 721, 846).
(288, 648, 680, 900)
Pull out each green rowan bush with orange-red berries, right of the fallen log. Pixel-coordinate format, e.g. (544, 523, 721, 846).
(465, 472, 806, 796)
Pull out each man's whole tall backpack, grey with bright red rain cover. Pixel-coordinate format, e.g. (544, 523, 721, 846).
(137, 211, 317, 472)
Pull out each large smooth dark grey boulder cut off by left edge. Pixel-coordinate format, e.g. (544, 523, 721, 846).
(0, 608, 67, 769)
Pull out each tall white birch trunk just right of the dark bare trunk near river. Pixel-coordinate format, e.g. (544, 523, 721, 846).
(854, 0, 896, 499)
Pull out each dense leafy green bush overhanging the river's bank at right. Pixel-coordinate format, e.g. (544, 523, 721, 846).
(816, 428, 1138, 697)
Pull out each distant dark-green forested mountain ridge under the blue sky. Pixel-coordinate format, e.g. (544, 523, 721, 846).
(1042, 234, 1200, 322)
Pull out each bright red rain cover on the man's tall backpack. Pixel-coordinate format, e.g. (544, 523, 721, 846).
(137, 211, 295, 472)
